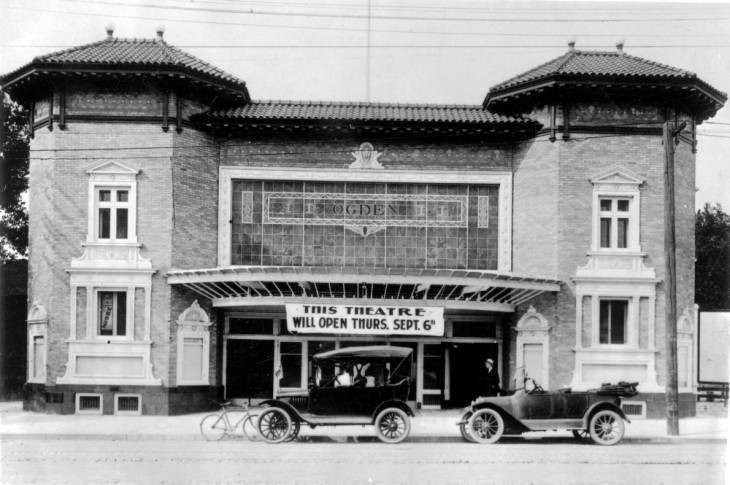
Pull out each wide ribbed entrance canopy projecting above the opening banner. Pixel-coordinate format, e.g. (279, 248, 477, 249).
(167, 266, 560, 312)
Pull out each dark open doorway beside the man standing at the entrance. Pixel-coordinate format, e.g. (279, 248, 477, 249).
(449, 343, 503, 406)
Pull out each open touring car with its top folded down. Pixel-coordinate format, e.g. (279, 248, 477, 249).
(457, 377, 637, 445)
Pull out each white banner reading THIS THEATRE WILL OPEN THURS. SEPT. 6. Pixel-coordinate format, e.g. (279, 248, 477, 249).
(286, 303, 444, 337)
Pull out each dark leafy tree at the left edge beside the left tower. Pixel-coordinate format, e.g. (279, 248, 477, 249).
(0, 91, 30, 261)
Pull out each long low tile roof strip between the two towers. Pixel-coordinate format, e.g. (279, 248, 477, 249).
(199, 101, 535, 124)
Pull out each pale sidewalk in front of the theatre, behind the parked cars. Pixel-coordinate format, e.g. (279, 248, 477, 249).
(0, 402, 730, 443)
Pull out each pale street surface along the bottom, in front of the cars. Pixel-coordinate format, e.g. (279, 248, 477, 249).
(0, 438, 726, 485)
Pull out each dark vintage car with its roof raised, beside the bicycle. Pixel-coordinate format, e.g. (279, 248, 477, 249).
(256, 345, 413, 443)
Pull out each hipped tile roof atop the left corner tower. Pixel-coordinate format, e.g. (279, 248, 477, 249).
(0, 37, 246, 95)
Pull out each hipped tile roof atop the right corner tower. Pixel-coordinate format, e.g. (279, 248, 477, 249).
(490, 50, 697, 91)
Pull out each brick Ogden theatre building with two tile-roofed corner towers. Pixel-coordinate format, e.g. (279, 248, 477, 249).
(0, 32, 726, 416)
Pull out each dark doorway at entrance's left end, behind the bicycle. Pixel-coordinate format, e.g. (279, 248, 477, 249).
(225, 339, 274, 399)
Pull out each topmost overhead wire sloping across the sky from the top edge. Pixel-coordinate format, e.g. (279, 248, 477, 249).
(64, 0, 730, 23)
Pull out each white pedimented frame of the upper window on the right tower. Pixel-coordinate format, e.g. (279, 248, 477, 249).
(591, 169, 643, 254)
